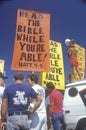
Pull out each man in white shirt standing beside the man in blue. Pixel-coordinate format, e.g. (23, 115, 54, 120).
(27, 73, 47, 130)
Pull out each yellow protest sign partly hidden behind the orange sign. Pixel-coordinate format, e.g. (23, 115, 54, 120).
(40, 40, 65, 90)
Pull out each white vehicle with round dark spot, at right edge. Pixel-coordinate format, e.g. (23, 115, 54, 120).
(63, 80, 86, 130)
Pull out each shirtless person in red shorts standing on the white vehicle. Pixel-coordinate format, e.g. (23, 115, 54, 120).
(65, 39, 81, 80)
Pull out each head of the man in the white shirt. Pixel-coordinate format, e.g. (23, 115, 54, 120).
(27, 74, 38, 86)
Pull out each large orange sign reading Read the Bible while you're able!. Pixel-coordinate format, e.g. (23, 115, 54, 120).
(11, 9, 50, 72)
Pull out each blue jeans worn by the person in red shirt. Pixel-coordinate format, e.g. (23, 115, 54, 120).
(52, 113, 63, 130)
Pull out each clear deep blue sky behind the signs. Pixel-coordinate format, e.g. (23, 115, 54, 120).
(0, 0, 86, 85)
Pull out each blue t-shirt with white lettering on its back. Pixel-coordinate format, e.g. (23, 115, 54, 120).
(3, 83, 38, 113)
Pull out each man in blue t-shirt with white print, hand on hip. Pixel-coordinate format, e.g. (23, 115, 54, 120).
(1, 72, 42, 130)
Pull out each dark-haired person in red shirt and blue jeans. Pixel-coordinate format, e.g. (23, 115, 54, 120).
(46, 82, 63, 130)
